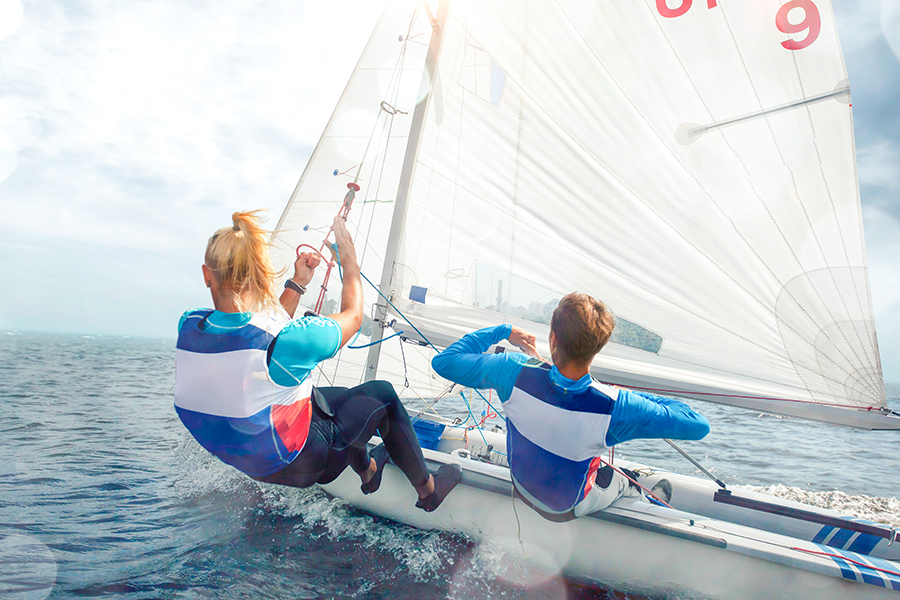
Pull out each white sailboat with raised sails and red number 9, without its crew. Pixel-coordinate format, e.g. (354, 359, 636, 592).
(272, 0, 900, 598)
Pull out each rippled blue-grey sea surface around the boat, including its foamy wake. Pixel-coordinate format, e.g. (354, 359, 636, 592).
(0, 332, 900, 600)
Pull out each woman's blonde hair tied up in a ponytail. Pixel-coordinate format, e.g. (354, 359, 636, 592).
(205, 210, 281, 312)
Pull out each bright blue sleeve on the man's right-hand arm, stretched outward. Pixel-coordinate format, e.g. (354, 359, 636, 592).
(606, 389, 709, 446)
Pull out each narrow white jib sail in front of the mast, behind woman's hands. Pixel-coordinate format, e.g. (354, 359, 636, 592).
(272, 2, 449, 398)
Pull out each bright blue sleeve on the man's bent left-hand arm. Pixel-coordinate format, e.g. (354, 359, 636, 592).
(431, 325, 528, 402)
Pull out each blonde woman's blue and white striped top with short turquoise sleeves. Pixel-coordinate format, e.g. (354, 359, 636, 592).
(175, 309, 341, 477)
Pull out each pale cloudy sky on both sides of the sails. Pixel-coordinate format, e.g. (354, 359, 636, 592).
(0, 0, 900, 381)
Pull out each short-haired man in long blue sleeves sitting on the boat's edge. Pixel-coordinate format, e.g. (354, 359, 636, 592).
(432, 293, 709, 520)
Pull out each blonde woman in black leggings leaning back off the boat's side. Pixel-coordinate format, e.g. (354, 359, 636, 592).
(175, 211, 461, 512)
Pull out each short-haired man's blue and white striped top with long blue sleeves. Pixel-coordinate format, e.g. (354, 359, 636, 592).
(431, 325, 709, 513)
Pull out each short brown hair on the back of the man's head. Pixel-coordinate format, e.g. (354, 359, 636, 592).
(550, 292, 616, 365)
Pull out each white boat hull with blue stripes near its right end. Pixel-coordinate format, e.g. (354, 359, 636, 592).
(324, 426, 900, 600)
